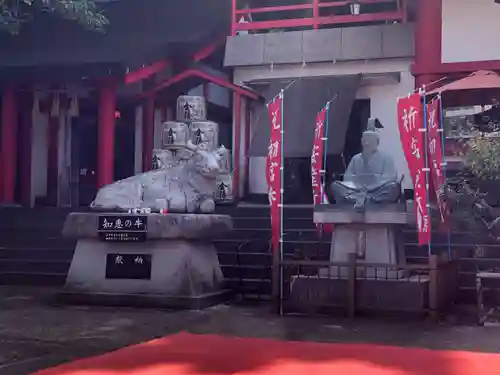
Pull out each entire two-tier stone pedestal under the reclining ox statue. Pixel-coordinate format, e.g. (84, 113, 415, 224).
(57, 213, 232, 308)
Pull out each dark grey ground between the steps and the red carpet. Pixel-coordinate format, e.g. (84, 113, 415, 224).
(0, 287, 500, 375)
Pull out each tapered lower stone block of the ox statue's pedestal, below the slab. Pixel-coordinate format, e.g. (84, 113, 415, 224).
(63, 239, 227, 308)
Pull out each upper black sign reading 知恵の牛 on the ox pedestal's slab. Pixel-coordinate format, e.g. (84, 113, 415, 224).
(97, 215, 147, 242)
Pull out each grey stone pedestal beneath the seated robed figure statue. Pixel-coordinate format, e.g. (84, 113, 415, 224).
(314, 204, 409, 279)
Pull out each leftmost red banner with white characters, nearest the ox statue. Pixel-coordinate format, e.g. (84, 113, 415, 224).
(266, 97, 283, 251)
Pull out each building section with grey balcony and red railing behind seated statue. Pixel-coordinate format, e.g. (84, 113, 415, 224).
(225, 0, 500, 203)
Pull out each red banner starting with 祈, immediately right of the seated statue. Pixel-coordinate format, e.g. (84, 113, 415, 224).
(398, 94, 431, 245)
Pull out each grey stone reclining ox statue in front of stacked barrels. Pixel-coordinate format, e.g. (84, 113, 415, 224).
(90, 142, 224, 213)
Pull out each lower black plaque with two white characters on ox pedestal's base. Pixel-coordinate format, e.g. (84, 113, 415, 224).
(106, 254, 152, 280)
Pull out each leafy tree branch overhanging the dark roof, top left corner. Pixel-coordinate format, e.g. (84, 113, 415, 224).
(0, 0, 108, 34)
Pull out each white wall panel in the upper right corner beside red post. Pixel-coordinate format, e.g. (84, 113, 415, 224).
(442, 0, 500, 63)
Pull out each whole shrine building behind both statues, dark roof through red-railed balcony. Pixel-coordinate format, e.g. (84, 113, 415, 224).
(0, 0, 500, 207)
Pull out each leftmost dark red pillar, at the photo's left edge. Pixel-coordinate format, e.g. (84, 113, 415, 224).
(1, 85, 18, 203)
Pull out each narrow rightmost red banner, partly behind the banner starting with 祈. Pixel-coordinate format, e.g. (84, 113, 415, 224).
(427, 98, 448, 229)
